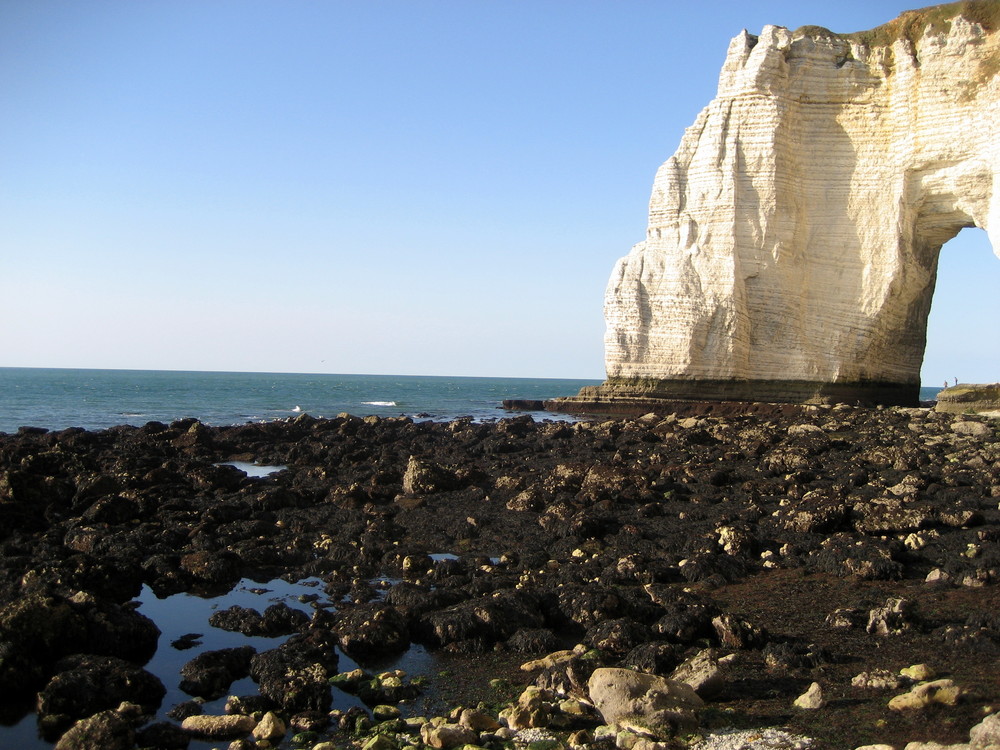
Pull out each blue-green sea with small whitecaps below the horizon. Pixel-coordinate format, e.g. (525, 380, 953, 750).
(0, 367, 941, 433)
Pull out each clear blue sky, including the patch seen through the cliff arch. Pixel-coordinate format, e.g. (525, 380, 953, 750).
(0, 0, 1000, 385)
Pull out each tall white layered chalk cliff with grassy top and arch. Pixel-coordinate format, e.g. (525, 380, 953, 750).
(591, 2, 1000, 403)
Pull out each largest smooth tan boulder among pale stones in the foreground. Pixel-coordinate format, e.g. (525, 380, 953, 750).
(588, 668, 704, 739)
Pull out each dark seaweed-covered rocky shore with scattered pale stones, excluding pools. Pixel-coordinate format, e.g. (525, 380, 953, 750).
(0, 406, 1000, 750)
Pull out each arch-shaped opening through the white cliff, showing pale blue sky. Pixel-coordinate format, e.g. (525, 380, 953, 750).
(920, 227, 1000, 390)
